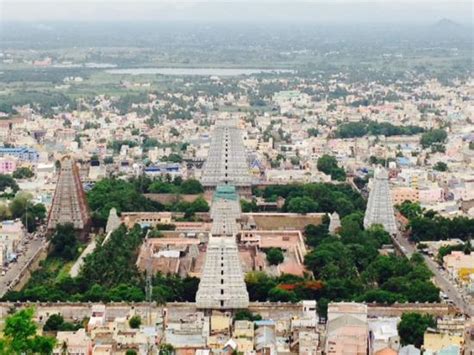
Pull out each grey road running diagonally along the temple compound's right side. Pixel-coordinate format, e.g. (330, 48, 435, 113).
(392, 233, 474, 318)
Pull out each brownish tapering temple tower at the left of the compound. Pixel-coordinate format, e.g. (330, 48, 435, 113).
(48, 156, 91, 238)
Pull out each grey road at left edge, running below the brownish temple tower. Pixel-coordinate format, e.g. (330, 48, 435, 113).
(0, 238, 45, 297)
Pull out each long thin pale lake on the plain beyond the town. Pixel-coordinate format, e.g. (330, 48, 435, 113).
(106, 68, 294, 76)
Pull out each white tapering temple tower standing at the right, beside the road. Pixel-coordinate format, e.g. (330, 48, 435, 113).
(364, 168, 397, 235)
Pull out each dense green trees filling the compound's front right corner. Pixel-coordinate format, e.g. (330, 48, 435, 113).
(295, 221, 439, 316)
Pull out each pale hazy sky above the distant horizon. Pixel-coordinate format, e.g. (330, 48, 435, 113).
(0, 0, 473, 25)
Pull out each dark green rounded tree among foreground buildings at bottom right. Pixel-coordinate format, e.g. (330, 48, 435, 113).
(398, 313, 436, 348)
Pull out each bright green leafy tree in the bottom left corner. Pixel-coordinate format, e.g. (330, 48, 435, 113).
(0, 308, 55, 354)
